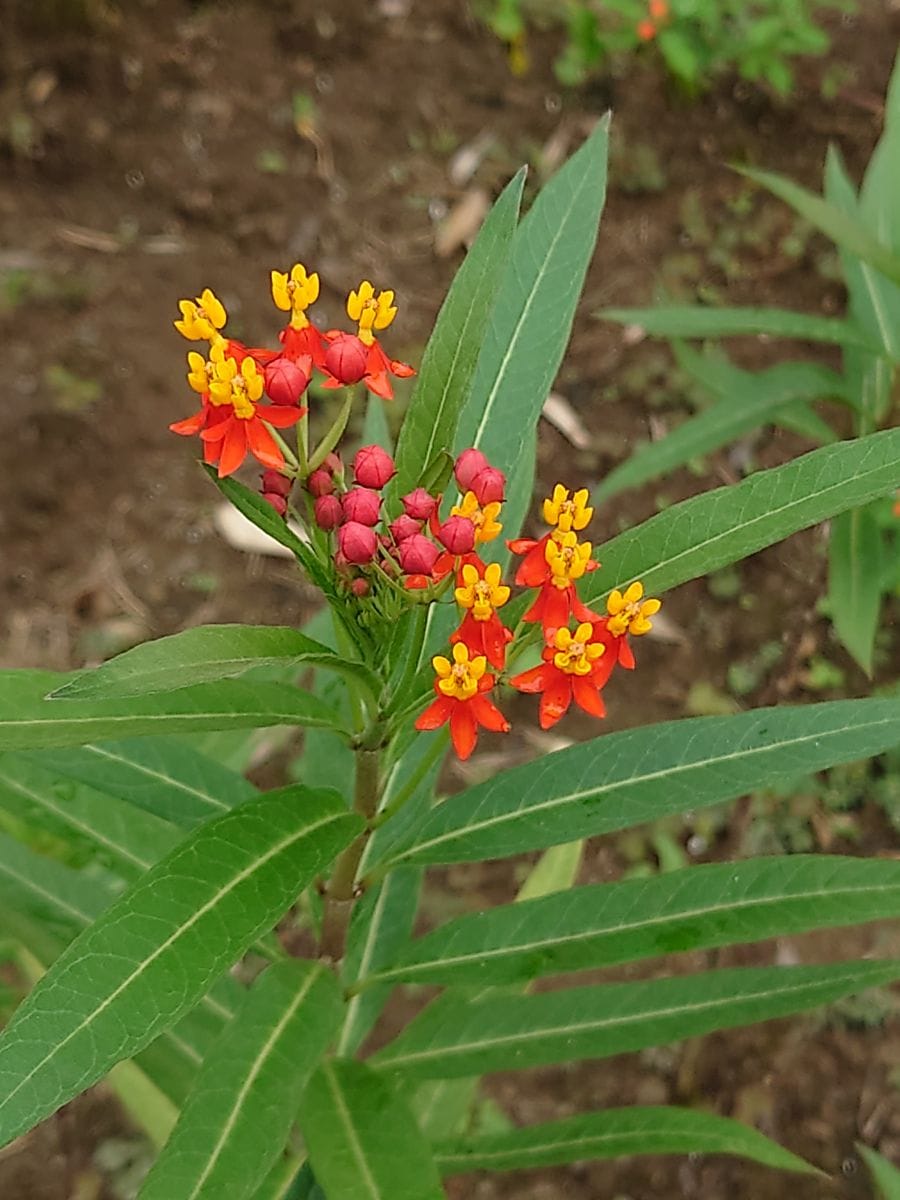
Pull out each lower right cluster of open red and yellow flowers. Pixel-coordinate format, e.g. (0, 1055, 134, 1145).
(415, 460, 660, 758)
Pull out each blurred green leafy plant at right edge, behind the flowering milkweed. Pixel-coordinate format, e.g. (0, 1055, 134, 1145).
(602, 49, 900, 672)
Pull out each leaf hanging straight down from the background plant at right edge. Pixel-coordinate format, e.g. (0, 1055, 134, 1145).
(828, 506, 883, 676)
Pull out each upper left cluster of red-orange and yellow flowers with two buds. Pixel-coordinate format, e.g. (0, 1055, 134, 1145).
(169, 263, 415, 477)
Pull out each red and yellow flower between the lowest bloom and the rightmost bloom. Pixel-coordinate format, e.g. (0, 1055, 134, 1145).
(510, 620, 608, 730)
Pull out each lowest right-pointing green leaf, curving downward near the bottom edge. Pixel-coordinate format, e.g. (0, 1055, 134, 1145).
(434, 1106, 815, 1175)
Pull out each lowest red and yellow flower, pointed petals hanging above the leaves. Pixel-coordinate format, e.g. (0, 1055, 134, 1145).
(415, 642, 509, 760)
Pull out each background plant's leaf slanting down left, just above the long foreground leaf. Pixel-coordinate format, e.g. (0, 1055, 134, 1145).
(593, 354, 844, 504)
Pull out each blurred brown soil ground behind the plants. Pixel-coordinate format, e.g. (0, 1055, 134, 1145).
(0, 0, 900, 1200)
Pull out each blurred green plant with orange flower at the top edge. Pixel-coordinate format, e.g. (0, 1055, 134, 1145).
(485, 0, 856, 95)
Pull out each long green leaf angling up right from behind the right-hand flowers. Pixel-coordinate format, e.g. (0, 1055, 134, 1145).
(582, 430, 900, 604)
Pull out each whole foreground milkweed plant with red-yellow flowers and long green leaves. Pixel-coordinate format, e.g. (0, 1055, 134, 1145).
(0, 114, 900, 1200)
